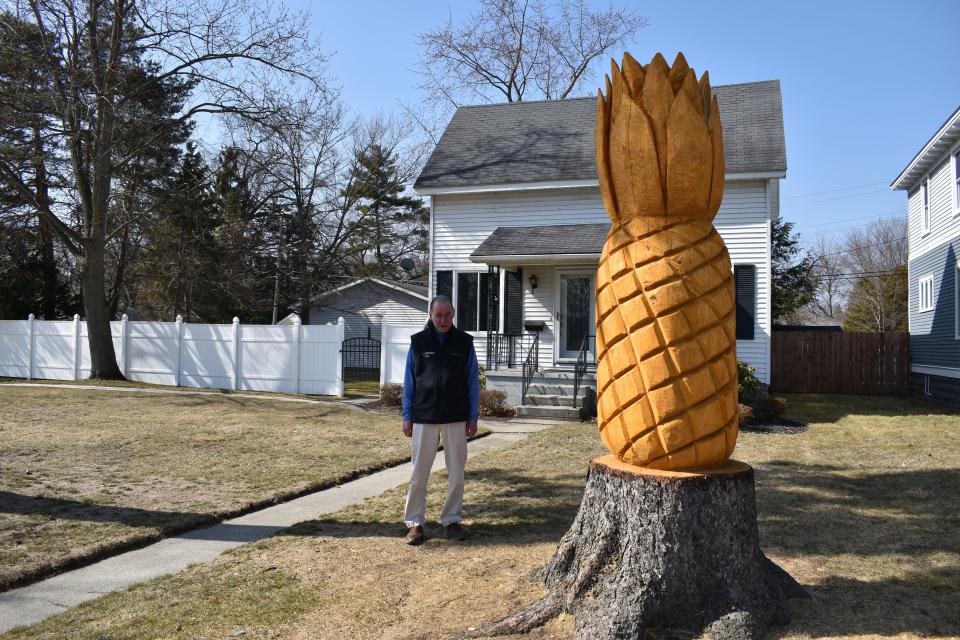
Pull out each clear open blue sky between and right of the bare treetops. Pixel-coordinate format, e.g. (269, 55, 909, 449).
(299, 0, 960, 248)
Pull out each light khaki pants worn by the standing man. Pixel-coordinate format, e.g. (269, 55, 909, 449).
(403, 422, 467, 527)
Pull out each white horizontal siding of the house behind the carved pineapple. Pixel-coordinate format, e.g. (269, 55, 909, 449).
(431, 181, 778, 382)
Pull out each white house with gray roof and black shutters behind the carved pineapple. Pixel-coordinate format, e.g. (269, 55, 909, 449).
(414, 80, 787, 410)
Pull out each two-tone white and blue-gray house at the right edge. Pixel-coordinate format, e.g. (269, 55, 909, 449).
(891, 108, 960, 408)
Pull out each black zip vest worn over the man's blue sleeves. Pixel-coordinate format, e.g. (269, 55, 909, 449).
(410, 327, 473, 424)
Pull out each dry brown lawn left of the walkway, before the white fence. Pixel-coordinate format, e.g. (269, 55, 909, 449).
(0, 385, 409, 589)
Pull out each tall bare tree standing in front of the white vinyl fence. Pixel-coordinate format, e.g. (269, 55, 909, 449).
(0, 0, 323, 378)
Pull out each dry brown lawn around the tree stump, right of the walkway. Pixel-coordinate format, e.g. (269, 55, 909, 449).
(3, 396, 960, 640)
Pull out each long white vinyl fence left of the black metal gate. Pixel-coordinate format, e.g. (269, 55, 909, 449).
(0, 314, 344, 396)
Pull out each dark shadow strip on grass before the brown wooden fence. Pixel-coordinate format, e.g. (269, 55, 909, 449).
(774, 393, 960, 423)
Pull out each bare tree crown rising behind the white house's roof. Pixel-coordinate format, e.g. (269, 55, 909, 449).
(419, 0, 647, 106)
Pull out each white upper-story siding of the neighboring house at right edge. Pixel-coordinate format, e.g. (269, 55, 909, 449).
(907, 150, 960, 260)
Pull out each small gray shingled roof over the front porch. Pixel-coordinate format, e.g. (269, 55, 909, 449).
(470, 223, 610, 258)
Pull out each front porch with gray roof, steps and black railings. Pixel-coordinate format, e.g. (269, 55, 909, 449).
(470, 224, 609, 418)
